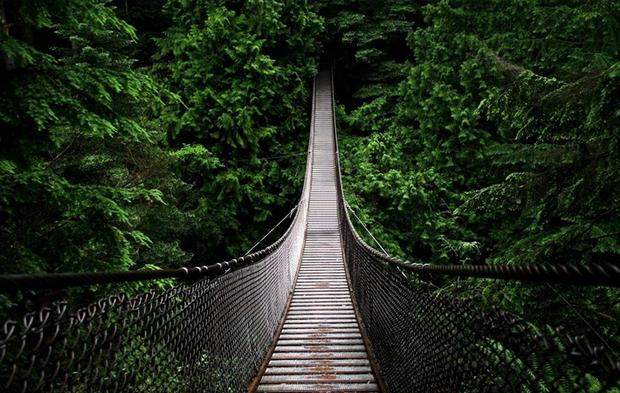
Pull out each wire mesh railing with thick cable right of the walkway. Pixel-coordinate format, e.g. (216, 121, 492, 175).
(332, 67, 620, 393)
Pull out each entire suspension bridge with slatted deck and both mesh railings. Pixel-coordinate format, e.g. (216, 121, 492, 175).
(0, 70, 620, 393)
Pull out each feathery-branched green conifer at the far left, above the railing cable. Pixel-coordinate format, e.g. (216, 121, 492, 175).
(0, 1, 187, 273)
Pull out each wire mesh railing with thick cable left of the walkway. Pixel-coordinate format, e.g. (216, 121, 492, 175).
(0, 82, 314, 393)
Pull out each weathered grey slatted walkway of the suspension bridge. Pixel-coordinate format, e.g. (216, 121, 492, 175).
(257, 71, 379, 393)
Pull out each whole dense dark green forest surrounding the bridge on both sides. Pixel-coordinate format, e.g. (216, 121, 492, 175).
(0, 0, 620, 358)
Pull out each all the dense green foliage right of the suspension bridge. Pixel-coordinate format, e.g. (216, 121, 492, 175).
(326, 0, 620, 348)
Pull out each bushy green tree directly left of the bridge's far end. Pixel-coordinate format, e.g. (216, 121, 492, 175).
(155, 1, 322, 260)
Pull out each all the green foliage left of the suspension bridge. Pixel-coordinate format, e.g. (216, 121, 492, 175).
(0, 0, 322, 310)
